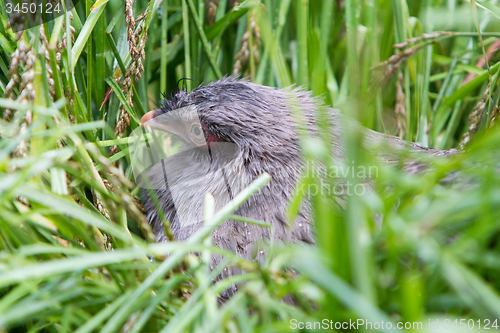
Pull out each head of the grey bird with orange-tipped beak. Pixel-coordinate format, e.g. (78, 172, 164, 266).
(141, 78, 304, 163)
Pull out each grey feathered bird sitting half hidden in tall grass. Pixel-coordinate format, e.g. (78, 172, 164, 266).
(135, 77, 455, 294)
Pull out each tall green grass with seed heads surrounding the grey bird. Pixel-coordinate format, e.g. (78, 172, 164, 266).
(0, 0, 500, 332)
